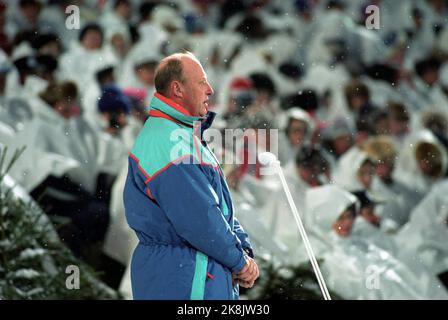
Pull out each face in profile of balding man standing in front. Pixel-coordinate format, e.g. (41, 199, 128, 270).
(182, 58, 213, 117)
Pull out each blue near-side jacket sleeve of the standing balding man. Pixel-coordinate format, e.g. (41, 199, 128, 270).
(149, 163, 246, 272)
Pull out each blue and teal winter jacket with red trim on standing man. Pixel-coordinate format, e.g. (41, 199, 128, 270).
(124, 93, 252, 300)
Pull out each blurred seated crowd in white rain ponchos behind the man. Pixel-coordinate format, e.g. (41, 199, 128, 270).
(0, 0, 448, 299)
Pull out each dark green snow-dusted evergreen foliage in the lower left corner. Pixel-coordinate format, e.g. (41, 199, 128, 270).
(0, 150, 119, 299)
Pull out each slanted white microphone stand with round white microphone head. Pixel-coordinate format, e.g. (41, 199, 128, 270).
(259, 152, 331, 300)
